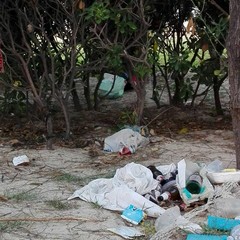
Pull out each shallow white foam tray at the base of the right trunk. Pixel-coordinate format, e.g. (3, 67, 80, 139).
(207, 170, 240, 184)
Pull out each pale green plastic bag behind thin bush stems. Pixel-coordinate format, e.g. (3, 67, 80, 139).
(98, 73, 126, 99)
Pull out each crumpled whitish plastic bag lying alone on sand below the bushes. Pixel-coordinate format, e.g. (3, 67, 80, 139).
(103, 128, 149, 152)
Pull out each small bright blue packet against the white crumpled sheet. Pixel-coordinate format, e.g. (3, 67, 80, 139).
(121, 204, 145, 225)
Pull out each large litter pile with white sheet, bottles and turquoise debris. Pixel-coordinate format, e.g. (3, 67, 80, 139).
(69, 159, 240, 240)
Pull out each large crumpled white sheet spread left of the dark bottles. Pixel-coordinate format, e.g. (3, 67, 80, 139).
(68, 163, 165, 217)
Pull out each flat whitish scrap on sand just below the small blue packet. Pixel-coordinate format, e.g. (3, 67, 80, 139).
(107, 226, 145, 239)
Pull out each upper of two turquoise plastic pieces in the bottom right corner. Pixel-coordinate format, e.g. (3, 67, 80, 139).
(207, 216, 240, 231)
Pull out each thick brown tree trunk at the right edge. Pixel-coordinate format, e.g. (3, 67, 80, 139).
(227, 0, 240, 169)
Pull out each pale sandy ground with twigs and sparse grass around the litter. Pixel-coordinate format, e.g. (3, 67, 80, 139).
(0, 78, 236, 240)
